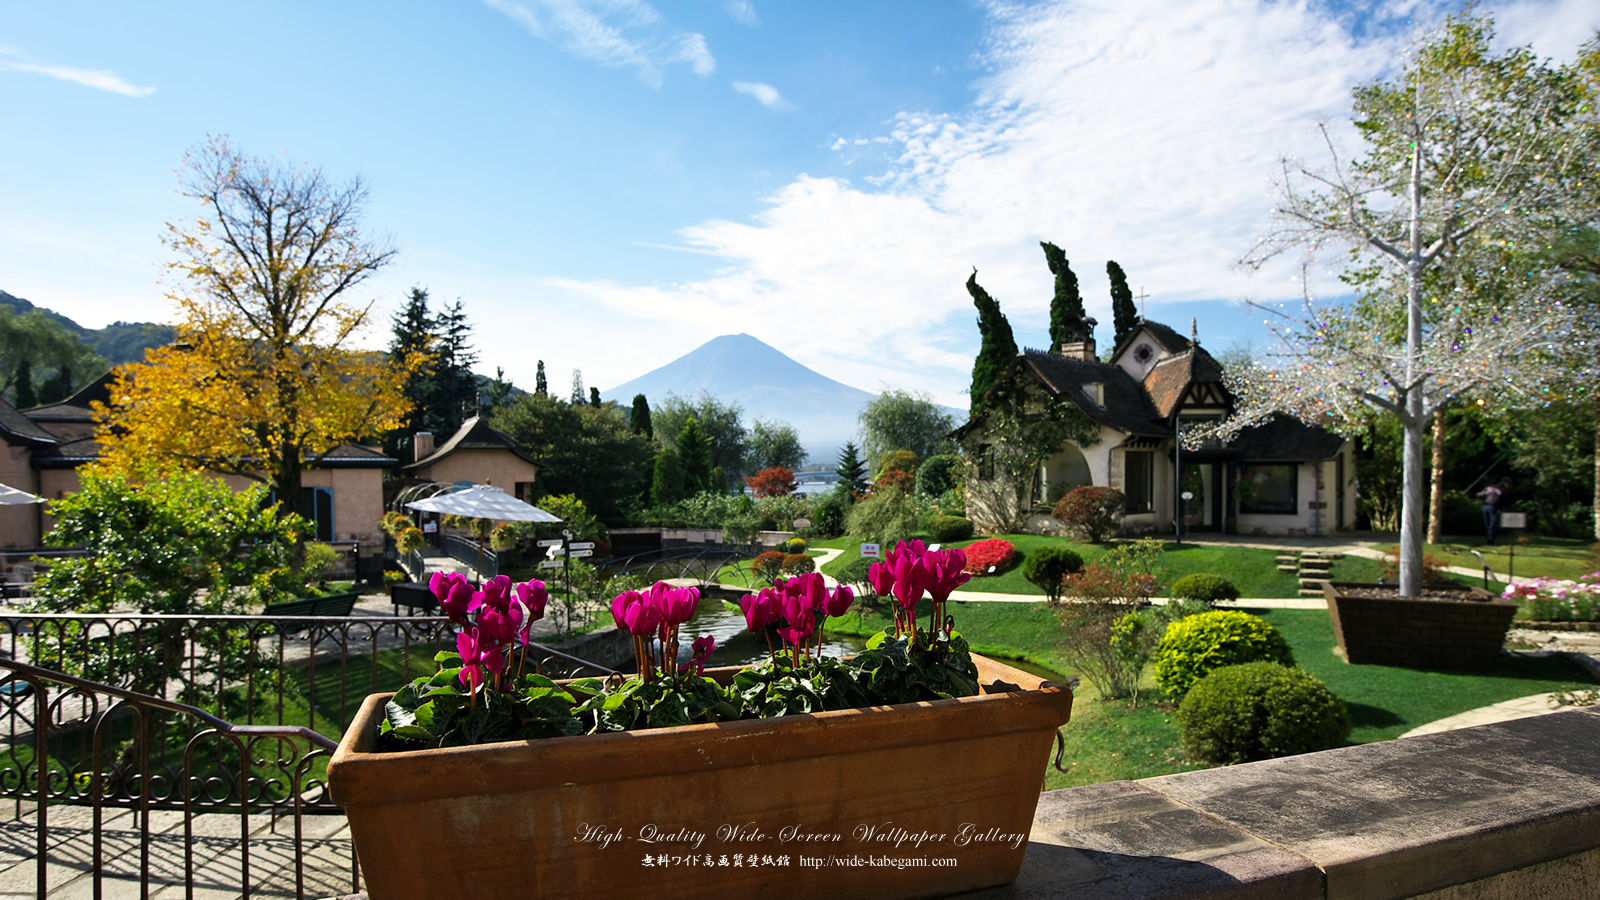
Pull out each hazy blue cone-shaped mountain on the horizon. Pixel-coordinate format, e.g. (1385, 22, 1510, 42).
(600, 335, 965, 466)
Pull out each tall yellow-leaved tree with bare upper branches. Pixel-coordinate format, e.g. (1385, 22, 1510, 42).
(96, 138, 422, 506)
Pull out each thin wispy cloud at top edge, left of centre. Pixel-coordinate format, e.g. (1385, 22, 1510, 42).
(483, 0, 717, 88)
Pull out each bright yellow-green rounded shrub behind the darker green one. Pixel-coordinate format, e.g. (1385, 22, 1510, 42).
(1155, 610, 1294, 700)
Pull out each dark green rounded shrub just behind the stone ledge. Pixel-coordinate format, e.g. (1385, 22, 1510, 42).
(1178, 663, 1350, 764)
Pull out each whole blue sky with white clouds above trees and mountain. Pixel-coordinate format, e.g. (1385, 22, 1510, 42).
(0, 0, 1600, 407)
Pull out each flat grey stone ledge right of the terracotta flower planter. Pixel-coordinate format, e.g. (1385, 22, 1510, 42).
(973, 706, 1600, 900)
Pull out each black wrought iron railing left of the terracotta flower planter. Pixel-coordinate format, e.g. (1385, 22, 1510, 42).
(0, 613, 610, 897)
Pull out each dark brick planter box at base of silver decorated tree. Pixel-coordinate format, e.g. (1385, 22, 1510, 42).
(1323, 583, 1517, 669)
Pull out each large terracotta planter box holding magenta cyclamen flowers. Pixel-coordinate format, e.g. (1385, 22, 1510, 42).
(328, 655, 1072, 900)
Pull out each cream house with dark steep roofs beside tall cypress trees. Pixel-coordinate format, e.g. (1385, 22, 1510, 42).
(957, 320, 1355, 535)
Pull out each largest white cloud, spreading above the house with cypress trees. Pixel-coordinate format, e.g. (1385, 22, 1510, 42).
(554, 0, 1576, 405)
